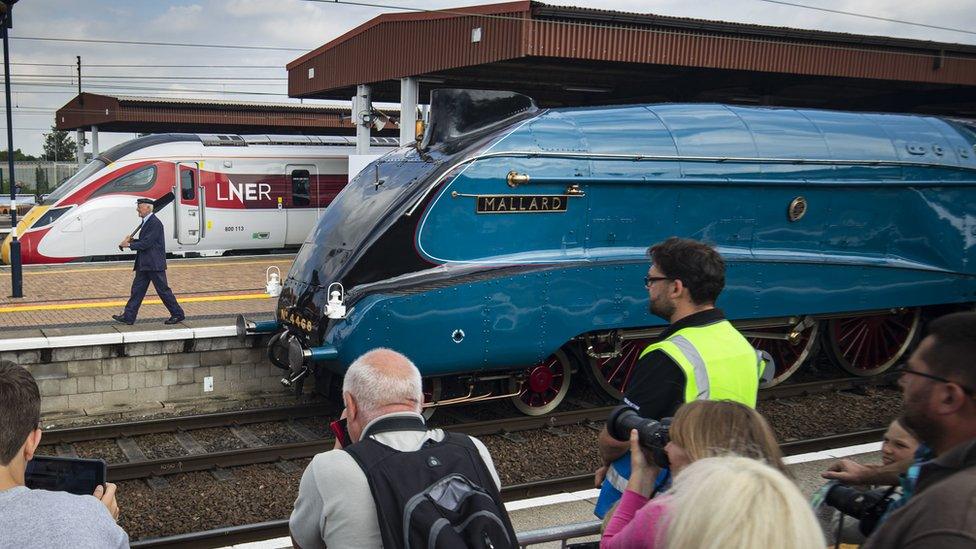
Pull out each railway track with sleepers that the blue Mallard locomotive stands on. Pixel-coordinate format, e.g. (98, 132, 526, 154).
(44, 376, 891, 482)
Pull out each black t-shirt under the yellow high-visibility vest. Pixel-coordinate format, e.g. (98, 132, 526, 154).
(624, 309, 725, 420)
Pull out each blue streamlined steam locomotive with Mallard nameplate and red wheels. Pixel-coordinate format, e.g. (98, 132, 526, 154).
(239, 90, 976, 414)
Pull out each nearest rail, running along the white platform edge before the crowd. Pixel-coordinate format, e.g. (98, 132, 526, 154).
(132, 428, 885, 549)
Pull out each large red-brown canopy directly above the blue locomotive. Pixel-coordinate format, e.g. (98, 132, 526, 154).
(288, 1, 976, 117)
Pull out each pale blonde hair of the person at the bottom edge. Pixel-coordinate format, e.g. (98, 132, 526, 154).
(663, 456, 826, 549)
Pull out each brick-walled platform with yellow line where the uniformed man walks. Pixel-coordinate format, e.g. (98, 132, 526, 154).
(0, 254, 306, 424)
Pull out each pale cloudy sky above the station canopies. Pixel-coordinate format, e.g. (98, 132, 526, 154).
(7, 0, 976, 154)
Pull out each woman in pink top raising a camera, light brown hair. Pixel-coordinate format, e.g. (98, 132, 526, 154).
(600, 400, 788, 549)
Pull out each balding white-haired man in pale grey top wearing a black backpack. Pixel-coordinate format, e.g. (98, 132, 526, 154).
(289, 349, 510, 549)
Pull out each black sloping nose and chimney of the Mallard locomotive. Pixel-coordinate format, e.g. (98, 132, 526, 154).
(239, 90, 537, 386)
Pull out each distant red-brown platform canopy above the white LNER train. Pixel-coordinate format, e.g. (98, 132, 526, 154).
(55, 93, 399, 135)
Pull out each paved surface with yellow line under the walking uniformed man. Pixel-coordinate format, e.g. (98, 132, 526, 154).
(0, 254, 294, 329)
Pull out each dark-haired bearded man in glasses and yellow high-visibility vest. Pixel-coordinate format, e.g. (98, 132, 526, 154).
(594, 237, 773, 518)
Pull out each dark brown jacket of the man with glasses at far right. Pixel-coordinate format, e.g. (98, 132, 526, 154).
(863, 439, 976, 549)
